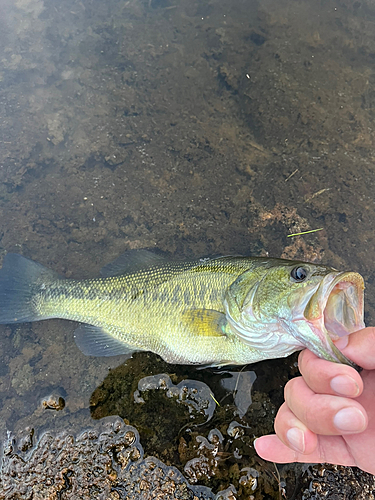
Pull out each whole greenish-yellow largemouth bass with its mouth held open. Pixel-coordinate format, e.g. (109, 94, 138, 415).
(0, 249, 365, 366)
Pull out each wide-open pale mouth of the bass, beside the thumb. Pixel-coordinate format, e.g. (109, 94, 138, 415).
(303, 272, 365, 366)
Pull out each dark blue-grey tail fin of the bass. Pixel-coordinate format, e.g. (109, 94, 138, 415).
(0, 253, 60, 324)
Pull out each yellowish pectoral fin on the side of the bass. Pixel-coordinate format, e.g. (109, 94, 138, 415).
(183, 309, 227, 337)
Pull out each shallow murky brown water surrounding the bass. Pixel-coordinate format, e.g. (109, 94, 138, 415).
(0, 0, 375, 500)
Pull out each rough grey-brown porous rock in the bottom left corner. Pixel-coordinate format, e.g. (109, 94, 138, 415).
(0, 417, 215, 500)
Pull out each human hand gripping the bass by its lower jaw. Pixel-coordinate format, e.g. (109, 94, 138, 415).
(254, 328, 375, 474)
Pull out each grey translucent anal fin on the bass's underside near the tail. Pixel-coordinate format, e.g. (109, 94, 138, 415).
(74, 323, 137, 357)
